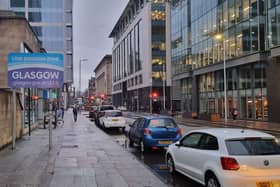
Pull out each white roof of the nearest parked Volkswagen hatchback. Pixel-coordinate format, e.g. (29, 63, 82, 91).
(190, 128, 274, 140)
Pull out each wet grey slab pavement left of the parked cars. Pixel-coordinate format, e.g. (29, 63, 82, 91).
(0, 111, 166, 187)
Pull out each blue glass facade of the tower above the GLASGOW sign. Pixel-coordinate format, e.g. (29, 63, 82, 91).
(10, 0, 73, 82)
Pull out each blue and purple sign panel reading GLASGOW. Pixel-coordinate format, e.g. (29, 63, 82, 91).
(8, 53, 64, 88)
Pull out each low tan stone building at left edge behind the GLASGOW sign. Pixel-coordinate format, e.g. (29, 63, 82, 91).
(0, 11, 41, 148)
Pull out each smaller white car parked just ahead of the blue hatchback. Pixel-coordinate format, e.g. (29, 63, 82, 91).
(99, 110, 126, 130)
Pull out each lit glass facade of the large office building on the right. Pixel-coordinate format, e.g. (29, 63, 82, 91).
(171, 0, 270, 120)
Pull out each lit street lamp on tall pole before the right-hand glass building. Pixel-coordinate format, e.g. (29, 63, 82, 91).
(214, 33, 228, 125)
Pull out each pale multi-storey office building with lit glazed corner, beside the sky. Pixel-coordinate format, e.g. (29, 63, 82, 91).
(110, 0, 171, 112)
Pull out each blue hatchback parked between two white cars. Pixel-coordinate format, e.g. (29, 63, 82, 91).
(128, 116, 182, 151)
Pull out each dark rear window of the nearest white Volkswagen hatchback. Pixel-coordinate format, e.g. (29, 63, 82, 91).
(226, 138, 280, 155)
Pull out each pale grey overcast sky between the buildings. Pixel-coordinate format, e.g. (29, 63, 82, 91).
(73, 0, 128, 91)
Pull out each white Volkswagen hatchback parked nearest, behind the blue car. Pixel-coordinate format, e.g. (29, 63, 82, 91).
(166, 128, 280, 187)
